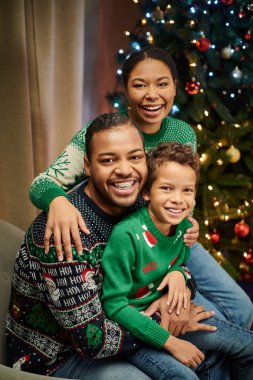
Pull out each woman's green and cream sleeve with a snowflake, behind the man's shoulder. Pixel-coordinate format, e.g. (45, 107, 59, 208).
(29, 123, 90, 212)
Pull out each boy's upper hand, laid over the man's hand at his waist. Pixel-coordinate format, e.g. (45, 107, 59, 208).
(157, 271, 187, 315)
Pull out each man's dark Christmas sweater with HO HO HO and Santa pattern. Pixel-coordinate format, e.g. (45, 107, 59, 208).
(7, 185, 136, 375)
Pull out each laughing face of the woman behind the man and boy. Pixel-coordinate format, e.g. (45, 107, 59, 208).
(126, 58, 176, 133)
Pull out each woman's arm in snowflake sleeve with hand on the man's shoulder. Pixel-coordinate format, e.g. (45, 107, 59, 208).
(30, 123, 89, 261)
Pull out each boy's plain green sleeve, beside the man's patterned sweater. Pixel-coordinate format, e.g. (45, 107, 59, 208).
(102, 224, 170, 348)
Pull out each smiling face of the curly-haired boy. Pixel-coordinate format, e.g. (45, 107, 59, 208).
(144, 162, 196, 235)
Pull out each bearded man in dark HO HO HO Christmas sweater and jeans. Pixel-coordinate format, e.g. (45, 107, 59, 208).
(7, 114, 212, 379)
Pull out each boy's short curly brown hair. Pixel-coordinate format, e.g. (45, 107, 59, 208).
(145, 142, 200, 192)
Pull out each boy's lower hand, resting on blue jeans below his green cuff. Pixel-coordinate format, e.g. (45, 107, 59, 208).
(163, 335, 205, 368)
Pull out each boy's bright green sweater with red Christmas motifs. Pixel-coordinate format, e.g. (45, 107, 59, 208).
(102, 207, 191, 348)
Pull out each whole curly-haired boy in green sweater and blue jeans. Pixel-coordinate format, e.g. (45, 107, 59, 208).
(102, 143, 253, 380)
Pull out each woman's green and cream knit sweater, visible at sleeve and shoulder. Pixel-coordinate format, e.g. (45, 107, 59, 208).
(30, 116, 196, 211)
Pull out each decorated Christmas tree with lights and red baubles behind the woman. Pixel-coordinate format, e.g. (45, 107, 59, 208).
(108, 0, 253, 281)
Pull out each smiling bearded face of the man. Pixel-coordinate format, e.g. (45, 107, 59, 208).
(84, 124, 147, 215)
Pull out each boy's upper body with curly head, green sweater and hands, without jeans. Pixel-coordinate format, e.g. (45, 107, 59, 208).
(102, 143, 204, 367)
